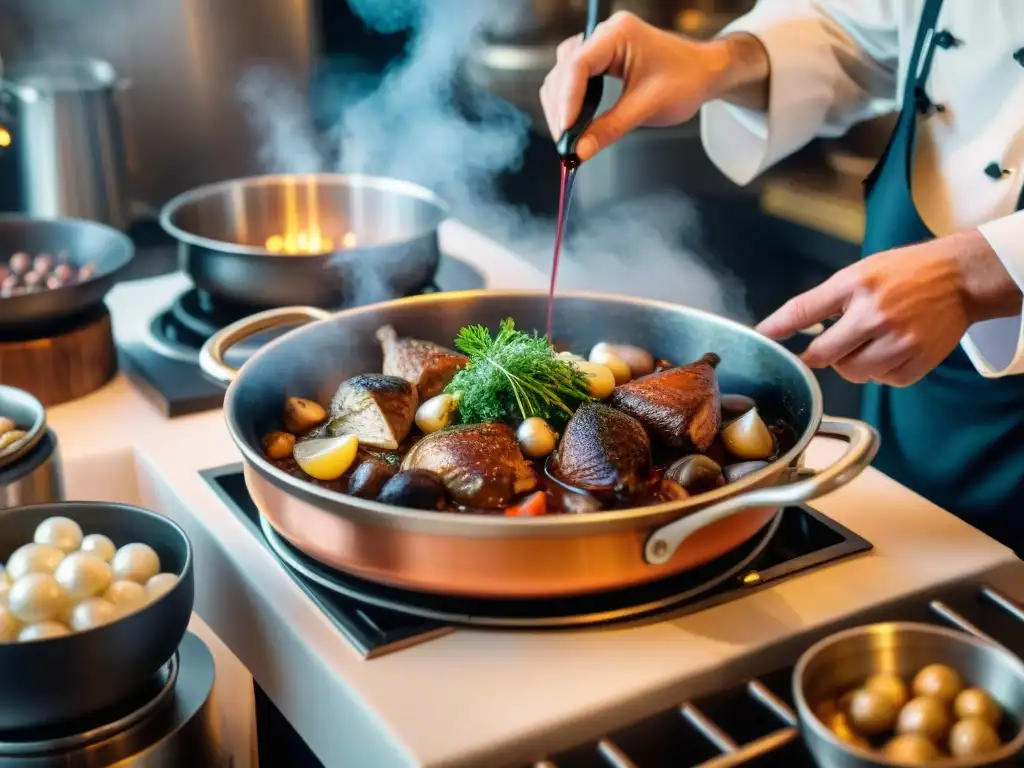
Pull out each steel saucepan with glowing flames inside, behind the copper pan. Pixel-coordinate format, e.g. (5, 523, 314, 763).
(160, 174, 447, 309)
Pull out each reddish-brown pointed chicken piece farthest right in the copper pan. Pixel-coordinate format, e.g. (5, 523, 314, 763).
(609, 352, 722, 453)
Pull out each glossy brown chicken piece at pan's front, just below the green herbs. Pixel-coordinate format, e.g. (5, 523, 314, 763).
(401, 424, 537, 509)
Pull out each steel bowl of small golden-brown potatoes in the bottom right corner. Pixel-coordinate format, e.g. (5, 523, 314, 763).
(793, 623, 1024, 768)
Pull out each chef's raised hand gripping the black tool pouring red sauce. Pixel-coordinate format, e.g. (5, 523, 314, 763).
(541, 11, 768, 161)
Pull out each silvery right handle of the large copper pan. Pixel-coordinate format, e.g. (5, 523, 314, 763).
(643, 416, 879, 565)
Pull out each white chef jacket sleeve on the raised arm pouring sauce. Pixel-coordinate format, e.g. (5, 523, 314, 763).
(700, 0, 899, 184)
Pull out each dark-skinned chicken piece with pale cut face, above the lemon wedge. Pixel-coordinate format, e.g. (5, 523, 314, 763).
(327, 374, 419, 451)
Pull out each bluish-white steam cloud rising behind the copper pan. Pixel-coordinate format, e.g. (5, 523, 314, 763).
(252, 0, 748, 318)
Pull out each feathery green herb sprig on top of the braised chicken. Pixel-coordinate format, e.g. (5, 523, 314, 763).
(445, 318, 590, 427)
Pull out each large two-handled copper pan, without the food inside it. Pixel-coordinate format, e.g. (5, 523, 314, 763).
(200, 291, 879, 598)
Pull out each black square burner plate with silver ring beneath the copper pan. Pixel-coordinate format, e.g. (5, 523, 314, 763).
(201, 465, 871, 658)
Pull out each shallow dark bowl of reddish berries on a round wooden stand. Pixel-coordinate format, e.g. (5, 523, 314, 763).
(0, 216, 135, 331)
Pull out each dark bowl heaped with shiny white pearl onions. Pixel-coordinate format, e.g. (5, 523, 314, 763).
(0, 502, 195, 730)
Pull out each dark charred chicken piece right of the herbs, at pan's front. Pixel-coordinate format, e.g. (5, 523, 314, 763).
(550, 402, 651, 496)
